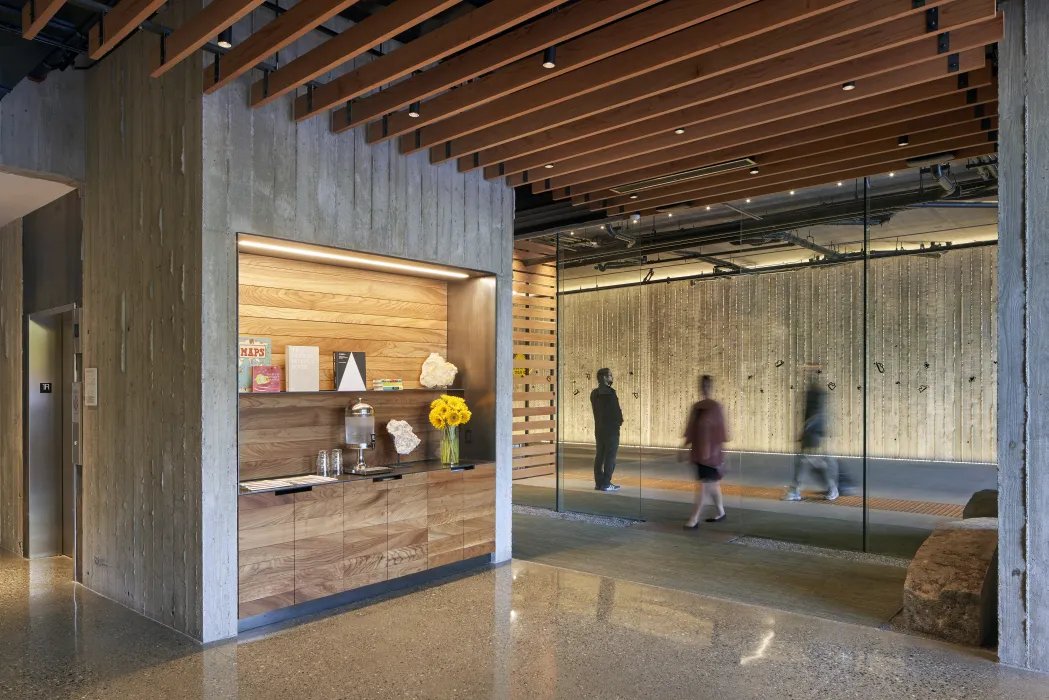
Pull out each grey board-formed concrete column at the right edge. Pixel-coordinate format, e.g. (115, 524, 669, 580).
(998, 0, 1049, 671)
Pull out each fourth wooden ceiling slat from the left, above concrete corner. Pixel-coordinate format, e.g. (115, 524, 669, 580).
(204, 0, 365, 94)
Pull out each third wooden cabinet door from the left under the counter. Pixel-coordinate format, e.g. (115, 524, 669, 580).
(342, 479, 389, 591)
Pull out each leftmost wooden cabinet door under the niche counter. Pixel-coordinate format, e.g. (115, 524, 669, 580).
(237, 493, 295, 617)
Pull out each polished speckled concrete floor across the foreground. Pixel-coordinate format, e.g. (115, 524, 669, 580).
(0, 558, 1049, 700)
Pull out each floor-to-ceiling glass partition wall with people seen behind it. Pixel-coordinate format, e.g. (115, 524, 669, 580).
(532, 175, 997, 556)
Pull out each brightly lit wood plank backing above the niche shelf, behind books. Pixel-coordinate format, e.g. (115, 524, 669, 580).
(238, 253, 448, 391)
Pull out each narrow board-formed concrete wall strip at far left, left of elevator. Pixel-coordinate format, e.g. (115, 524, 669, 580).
(0, 218, 23, 556)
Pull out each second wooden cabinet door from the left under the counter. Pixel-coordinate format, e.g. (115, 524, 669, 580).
(295, 484, 345, 603)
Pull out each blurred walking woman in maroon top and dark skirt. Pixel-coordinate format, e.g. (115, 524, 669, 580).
(685, 375, 728, 529)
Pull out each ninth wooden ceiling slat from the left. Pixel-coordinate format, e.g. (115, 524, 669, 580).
(402, 0, 780, 153)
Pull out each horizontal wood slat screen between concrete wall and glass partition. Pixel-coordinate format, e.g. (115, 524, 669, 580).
(513, 241, 557, 479)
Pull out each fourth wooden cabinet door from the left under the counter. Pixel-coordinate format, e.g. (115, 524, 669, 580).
(386, 473, 429, 578)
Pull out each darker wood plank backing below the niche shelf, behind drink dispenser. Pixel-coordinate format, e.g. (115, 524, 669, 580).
(239, 390, 453, 481)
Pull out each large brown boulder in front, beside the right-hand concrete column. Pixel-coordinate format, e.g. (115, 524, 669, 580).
(903, 517, 998, 646)
